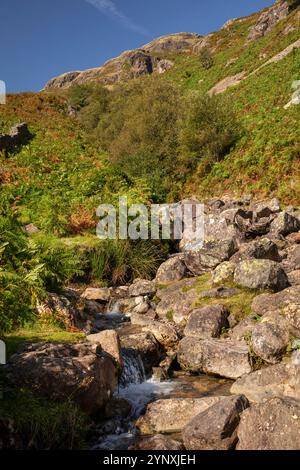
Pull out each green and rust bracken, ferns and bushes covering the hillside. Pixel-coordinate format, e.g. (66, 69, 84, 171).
(0, 2, 300, 329)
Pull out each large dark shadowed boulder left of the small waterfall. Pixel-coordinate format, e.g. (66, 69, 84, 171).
(5, 343, 118, 414)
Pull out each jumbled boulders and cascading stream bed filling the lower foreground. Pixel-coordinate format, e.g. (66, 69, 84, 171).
(0, 197, 300, 450)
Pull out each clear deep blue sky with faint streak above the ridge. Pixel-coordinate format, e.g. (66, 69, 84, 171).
(0, 0, 273, 92)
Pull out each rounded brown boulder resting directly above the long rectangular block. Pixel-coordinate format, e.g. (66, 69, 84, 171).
(184, 305, 229, 339)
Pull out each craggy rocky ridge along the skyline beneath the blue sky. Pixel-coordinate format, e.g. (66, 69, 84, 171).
(45, 0, 300, 91)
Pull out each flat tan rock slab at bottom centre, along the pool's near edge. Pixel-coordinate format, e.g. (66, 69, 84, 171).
(136, 397, 223, 434)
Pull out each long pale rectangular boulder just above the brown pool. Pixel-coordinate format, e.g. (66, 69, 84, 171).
(177, 336, 252, 380)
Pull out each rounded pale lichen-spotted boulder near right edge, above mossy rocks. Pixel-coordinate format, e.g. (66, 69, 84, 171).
(234, 259, 289, 292)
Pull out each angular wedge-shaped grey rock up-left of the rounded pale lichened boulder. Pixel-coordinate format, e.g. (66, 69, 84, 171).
(184, 240, 236, 276)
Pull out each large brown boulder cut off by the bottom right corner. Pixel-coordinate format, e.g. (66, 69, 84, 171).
(237, 398, 300, 450)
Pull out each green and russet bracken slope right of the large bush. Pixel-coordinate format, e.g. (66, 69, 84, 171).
(166, 8, 300, 204)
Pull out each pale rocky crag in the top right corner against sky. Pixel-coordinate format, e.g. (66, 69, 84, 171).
(248, 0, 300, 41)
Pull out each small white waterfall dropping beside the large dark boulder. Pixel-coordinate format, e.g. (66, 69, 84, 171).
(120, 349, 146, 388)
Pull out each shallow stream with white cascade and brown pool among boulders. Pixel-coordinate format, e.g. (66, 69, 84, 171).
(90, 312, 232, 451)
